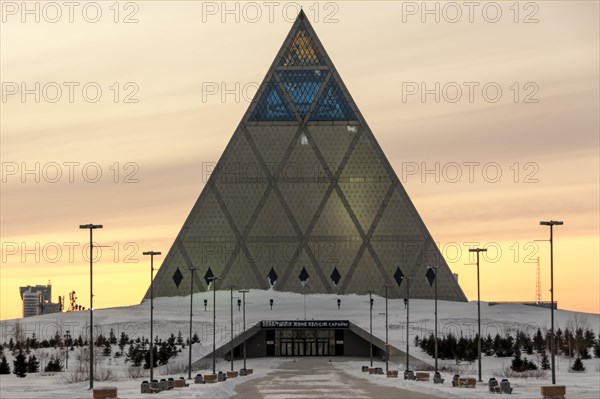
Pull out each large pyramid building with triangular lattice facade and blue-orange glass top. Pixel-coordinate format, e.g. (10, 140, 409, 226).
(146, 12, 466, 301)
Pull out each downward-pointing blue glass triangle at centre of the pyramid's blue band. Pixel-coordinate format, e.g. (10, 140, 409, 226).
(279, 70, 326, 118)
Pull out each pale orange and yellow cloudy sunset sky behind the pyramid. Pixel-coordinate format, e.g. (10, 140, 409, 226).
(0, 1, 600, 319)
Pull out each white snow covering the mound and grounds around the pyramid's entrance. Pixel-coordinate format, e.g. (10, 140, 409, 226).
(0, 290, 600, 398)
